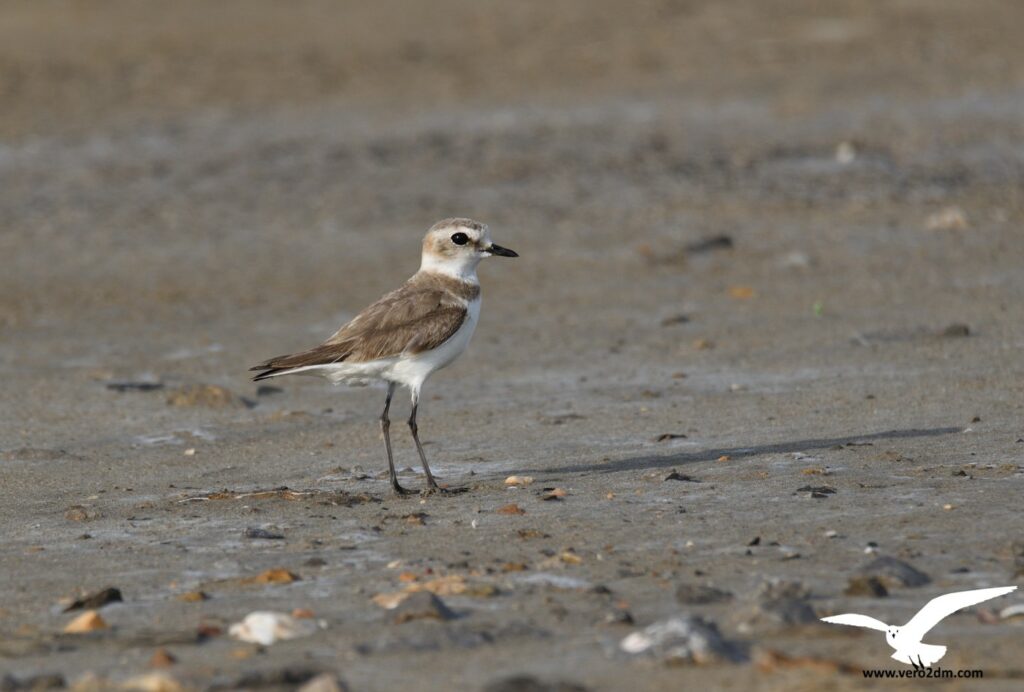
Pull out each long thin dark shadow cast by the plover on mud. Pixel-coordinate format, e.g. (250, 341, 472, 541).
(525, 428, 962, 473)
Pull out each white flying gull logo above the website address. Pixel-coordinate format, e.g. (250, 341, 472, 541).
(821, 587, 1017, 668)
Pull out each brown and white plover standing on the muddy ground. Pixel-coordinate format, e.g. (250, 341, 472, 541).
(250, 219, 519, 494)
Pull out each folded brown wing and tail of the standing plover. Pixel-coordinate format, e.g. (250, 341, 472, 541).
(250, 282, 466, 380)
